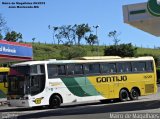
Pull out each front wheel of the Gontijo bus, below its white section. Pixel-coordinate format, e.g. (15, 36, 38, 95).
(49, 95, 61, 108)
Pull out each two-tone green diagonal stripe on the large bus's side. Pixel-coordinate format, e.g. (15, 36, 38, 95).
(62, 77, 99, 97)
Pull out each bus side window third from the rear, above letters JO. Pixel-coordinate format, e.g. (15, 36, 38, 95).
(117, 62, 131, 73)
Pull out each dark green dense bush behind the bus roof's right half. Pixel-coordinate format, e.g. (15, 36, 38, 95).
(104, 43, 137, 57)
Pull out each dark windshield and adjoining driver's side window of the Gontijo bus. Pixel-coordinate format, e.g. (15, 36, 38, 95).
(8, 65, 45, 95)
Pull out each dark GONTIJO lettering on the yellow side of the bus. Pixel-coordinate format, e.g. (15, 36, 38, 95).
(96, 76, 127, 83)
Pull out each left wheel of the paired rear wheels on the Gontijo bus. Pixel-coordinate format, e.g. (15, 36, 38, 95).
(119, 89, 129, 102)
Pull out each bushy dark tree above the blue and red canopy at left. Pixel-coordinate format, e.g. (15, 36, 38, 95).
(4, 31, 22, 42)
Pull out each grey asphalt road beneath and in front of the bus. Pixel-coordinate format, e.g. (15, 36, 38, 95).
(0, 86, 160, 119)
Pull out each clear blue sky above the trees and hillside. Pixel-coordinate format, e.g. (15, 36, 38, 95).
(0, 0, 160, 48)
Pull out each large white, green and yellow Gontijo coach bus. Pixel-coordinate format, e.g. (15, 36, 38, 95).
(8, 56, 157, 108)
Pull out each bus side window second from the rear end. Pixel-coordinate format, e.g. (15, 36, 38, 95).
(132, 62, 146, 72)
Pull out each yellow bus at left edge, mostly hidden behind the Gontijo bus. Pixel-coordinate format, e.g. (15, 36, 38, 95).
(0, 67, 9, 98)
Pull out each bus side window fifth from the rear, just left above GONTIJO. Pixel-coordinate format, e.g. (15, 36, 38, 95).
(84, 64, 100, 74)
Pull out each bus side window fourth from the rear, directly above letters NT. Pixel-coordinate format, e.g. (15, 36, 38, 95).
(101, 63, 116, 73)
